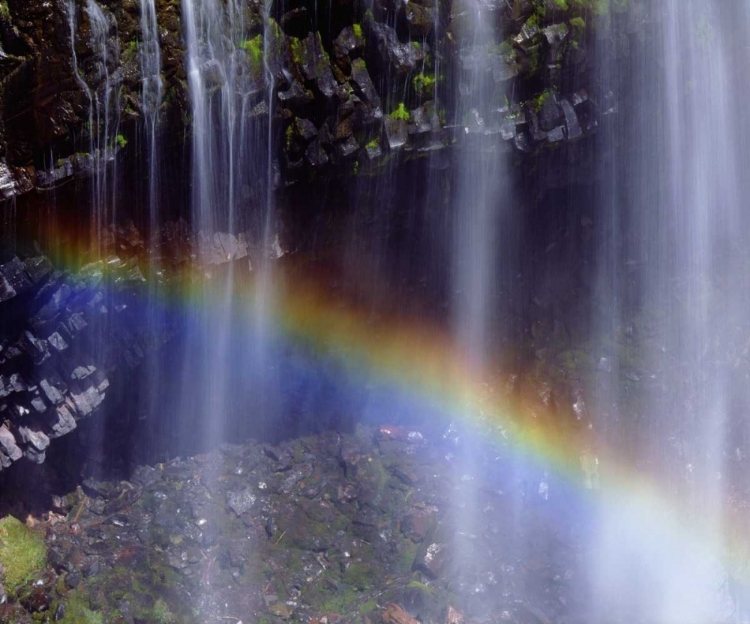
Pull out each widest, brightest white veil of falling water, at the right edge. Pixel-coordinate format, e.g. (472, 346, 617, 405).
(594, 0, 750, 623)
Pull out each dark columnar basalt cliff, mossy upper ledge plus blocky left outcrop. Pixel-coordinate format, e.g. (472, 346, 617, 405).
(0, 0, 653, 467)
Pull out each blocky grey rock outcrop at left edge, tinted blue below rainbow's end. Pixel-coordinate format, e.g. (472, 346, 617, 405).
(0, 227, 178, 468)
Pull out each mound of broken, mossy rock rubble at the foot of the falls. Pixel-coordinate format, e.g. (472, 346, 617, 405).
(0, 426, 585, 624)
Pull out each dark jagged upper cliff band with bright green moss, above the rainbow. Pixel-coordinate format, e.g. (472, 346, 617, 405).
(0, 0, 644, 199)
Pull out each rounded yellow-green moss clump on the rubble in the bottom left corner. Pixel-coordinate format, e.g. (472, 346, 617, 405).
(0, 516, 47, 590)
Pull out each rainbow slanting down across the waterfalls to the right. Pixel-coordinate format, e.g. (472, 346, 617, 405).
(35, 228, 750, 608)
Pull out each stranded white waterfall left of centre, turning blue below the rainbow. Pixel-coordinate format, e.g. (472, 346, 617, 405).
(181, 0, 277, 458)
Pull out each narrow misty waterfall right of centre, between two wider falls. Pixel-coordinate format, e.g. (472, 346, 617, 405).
(452, 2, 507, 595)
